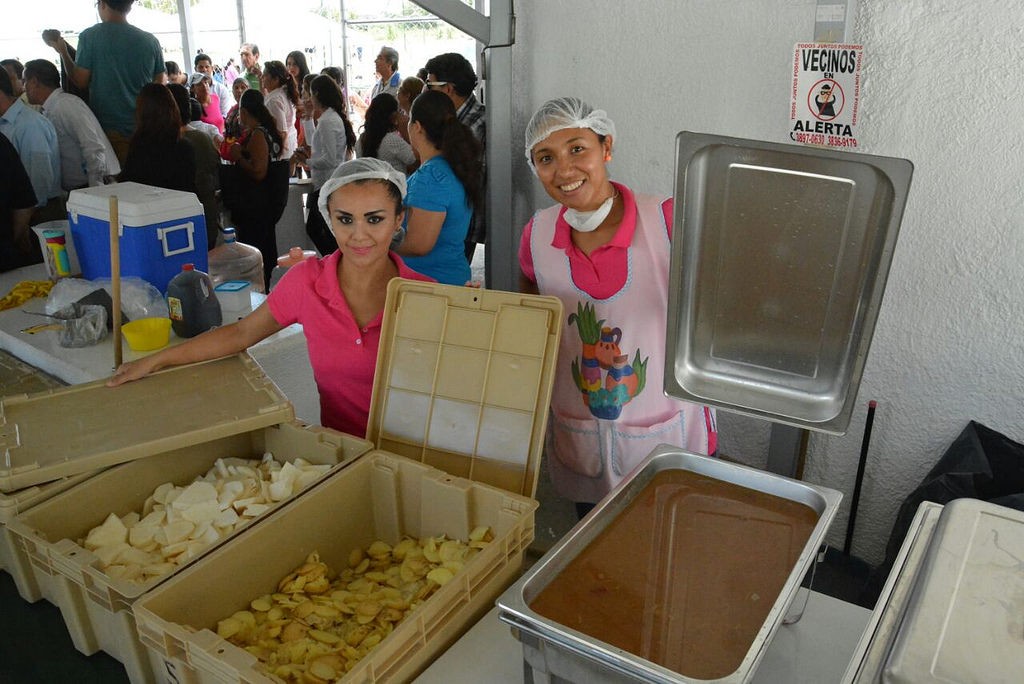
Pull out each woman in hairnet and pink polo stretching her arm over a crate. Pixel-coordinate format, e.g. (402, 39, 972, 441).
(106, 158, 433, 437)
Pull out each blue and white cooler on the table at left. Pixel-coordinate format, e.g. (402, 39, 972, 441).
(68, 182, 208, 292)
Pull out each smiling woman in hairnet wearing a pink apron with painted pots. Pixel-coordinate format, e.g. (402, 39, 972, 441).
(519, 97, 717, 516)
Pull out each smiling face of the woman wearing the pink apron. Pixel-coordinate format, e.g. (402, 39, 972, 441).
(530, 128, 612, 211)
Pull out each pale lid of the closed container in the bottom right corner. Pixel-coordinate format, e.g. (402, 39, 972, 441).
(882, 499, 1024, 684)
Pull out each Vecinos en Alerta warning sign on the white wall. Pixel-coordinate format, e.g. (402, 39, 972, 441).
(790, 43, 864, 147)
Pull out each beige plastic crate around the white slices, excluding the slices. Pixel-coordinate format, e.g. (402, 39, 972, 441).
(7, 422, 371, 684)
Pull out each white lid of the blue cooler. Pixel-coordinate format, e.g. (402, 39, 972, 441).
(68, 182, 203, 226)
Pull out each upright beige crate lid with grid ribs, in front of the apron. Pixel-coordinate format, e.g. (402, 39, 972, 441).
(367, 279, 562, 498)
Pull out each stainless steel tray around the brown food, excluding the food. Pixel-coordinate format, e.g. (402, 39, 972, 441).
(498, 445, 842, 684)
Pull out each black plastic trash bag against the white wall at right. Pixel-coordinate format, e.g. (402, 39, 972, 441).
(858, 421, 1024, 605)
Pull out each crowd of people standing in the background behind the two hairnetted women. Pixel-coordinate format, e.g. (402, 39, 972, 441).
(0, 0, 485, 286)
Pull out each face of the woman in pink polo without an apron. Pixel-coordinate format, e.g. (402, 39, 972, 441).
(327, 180, 403, 268)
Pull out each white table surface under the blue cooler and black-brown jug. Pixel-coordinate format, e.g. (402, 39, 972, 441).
(0, 264, 319, 424)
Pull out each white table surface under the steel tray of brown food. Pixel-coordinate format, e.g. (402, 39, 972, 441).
(415, 592, 871, 684)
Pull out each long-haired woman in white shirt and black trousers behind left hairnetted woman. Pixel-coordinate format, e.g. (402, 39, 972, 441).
(295, 75, 355, 256)
